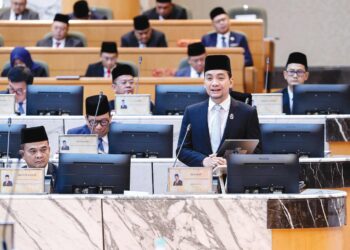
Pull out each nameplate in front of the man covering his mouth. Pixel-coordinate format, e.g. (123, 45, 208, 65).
(58, 134, 98, 154)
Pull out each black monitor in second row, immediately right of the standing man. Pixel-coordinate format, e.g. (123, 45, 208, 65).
(260, 123, 325, 157)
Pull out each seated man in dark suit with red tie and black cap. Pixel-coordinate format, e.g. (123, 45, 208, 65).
(85, 42, 121, 78)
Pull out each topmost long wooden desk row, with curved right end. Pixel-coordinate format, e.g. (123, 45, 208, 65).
(0, 19, 265, 92)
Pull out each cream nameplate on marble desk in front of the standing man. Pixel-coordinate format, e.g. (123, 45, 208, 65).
(168, 167, 213, 193)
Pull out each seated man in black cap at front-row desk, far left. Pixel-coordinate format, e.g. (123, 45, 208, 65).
(19, 126, 57, 175)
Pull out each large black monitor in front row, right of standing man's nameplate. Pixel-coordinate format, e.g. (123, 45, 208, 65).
(227, 154, 299, 193)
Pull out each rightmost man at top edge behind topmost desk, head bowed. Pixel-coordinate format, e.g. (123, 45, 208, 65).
(143, 0, 187, 20)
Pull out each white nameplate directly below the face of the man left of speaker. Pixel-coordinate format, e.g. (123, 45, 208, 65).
(114, 94, 151, 115)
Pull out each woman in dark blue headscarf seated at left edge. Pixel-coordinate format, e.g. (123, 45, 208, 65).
(1, 47, 48, 77)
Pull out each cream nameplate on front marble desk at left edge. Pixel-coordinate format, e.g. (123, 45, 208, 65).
(0, 168, 45, 194)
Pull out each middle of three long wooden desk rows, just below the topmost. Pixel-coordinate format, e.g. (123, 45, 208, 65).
(0, 47, 244, 92)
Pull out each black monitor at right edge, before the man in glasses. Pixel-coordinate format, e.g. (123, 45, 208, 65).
(293, 84, 350, 115)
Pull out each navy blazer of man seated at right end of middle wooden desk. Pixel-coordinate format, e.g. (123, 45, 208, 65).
(202, 31, 253, 66)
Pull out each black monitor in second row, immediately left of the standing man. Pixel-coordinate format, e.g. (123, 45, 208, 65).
(108, 123, 173, 158)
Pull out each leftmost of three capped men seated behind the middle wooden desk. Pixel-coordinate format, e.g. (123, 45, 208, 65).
(36, 13, 84, 48)
